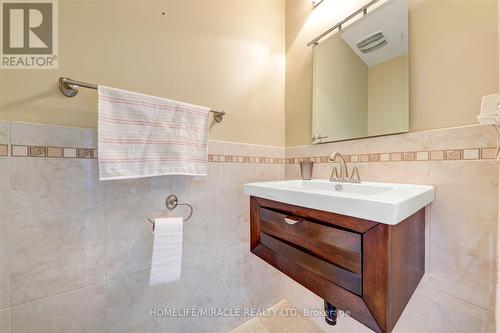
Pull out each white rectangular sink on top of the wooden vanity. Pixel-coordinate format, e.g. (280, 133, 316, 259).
(244, 179, 434, 225)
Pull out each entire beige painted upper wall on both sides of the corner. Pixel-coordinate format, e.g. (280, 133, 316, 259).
(0, 0, 498, 146)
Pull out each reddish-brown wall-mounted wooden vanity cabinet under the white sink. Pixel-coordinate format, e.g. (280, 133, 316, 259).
(250, 197, 425, 332)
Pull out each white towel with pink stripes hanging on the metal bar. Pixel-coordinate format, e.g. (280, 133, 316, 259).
(98, 86, 210, 180)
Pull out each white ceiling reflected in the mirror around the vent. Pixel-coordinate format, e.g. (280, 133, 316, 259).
(340, 0, 408, 67)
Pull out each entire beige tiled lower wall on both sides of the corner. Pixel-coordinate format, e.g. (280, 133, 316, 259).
(0, 122, 498, 333)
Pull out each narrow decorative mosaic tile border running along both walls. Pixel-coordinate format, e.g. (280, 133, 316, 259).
(0, 144, 497, 164)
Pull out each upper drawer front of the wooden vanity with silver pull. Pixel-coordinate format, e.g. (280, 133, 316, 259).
(259, 207, 361, 274)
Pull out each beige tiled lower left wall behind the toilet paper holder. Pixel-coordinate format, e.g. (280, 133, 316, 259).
(0, 122, 284, 333)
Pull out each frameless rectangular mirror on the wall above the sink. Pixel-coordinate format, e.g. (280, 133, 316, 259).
(312, 0, 409, 143)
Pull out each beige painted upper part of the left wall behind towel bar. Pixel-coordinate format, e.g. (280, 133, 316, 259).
(0, 0, 285, 146)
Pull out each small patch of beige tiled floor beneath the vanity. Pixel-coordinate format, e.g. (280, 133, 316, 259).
(230, 301, 324, 333)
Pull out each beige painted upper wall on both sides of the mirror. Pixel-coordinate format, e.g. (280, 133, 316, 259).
(285, 0, 499, 146)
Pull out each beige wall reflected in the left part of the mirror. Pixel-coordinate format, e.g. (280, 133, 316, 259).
(313, 34, 369, 140)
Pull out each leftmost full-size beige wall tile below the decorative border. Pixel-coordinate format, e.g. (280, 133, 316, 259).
(9, 158, 105, 305)
